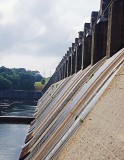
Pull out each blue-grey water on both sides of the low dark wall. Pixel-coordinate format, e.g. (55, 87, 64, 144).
(0, 102, 36, 160)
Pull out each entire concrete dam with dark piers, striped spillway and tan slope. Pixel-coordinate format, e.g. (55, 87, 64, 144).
(19, 0, 124, 160)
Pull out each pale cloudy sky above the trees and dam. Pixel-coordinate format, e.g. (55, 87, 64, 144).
(0, 0, 100, 77)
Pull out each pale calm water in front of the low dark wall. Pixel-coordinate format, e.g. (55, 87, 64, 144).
(0, 124, 29, 160)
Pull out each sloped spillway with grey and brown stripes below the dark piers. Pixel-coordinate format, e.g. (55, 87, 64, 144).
(20, 49, 124, 160)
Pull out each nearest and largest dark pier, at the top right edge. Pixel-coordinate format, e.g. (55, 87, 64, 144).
(107, 0, 124, 57)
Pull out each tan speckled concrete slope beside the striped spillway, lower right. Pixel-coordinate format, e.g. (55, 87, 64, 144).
(57, 65, 124, 160)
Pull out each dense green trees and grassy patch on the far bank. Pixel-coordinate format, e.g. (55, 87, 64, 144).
(0, 66, 48, 91)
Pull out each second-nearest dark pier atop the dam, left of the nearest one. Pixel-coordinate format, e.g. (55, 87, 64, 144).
(91, 0, 110, 65)
